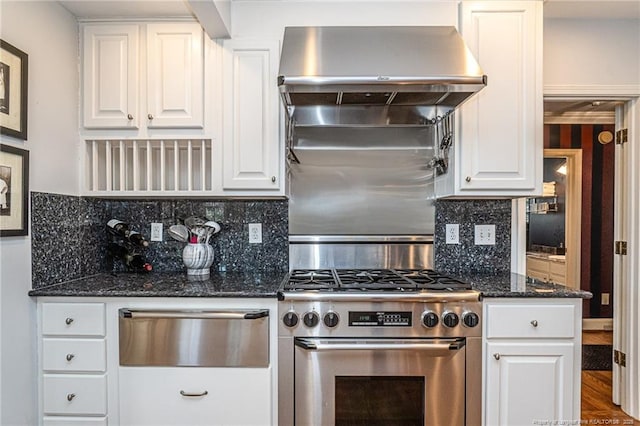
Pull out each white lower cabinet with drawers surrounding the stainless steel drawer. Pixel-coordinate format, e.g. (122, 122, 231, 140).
(37, 297, 277, 426)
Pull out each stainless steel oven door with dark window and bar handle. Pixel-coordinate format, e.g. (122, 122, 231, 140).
(294, 338, 466, 426)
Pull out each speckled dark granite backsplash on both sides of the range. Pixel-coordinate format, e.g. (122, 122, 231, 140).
(31, 192, 511, 289)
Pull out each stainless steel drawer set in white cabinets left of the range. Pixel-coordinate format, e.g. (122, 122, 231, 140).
(119, 309, 269, 367)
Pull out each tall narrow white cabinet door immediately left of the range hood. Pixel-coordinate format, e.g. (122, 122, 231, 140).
(223, 40, 280, 190)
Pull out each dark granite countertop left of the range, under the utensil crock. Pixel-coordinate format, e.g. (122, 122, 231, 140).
(29, 271, 286, 298)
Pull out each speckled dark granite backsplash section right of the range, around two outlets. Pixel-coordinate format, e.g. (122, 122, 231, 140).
(434, 200, 511, 274)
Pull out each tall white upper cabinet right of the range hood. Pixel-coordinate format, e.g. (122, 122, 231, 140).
(456, 1, 543, 196)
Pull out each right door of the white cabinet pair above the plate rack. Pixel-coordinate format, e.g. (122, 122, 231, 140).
(143, 23, 204, 128)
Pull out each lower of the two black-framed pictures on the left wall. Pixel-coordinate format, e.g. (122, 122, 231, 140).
(0, 144, 29, 237)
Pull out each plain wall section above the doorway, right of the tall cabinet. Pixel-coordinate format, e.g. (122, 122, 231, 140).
(544, 19, 640, 94)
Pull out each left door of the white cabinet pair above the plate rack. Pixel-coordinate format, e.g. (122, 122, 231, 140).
(83, 25, 139, 129)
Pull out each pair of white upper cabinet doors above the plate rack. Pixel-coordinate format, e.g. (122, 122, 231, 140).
(83, 22, 204, 129)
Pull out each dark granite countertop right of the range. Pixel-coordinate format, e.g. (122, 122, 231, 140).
(456, 273, 593, 299)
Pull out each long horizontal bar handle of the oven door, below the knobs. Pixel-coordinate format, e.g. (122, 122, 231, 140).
(295, 338, 466, 356)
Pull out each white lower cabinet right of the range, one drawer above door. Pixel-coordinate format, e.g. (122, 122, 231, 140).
(483, 298, 582, 426)
